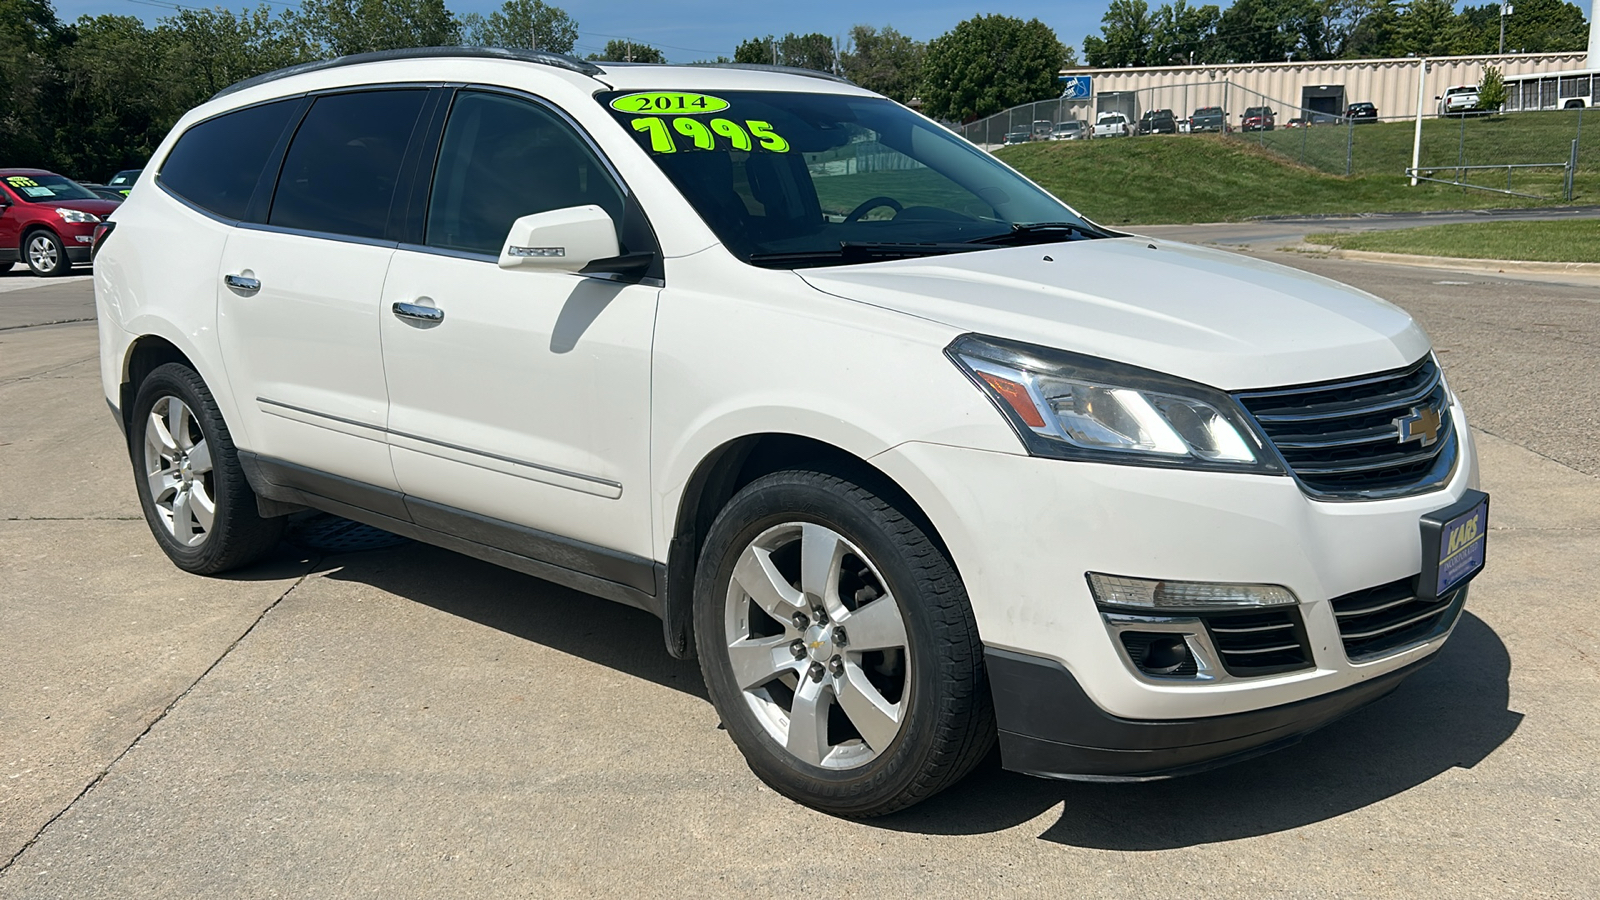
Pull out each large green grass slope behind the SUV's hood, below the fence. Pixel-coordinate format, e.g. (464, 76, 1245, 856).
(997, 137, 1574, 224)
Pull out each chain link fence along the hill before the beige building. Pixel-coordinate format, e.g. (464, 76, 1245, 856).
(957, 80, 1600, 203)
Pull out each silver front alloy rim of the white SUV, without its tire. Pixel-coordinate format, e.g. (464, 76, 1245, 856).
(725, 522, 912, 769)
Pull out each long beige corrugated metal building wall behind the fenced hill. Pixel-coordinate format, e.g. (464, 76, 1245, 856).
(1062, 53, 1586, 119)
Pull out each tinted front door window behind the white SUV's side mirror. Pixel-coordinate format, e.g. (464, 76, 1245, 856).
(426, 91, 622, 253)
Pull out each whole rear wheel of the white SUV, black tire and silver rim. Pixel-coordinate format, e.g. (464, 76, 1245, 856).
(128, 362, 283, 575)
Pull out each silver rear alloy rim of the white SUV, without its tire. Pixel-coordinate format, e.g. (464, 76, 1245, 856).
(144, 396, 216, 548)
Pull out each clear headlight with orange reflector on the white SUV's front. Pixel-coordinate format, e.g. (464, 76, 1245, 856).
(946, 335, 1283, 474)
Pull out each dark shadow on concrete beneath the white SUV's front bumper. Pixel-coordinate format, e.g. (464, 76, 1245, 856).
(870, 613, 1522, 850)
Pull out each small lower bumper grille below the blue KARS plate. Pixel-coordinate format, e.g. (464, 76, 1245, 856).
(1333, 578, 1467, 663)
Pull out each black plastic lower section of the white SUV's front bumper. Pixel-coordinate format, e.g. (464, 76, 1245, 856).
(984, 649, 1432, 781)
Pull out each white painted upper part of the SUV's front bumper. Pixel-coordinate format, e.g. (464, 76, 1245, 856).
(872, 392, 1477, 730)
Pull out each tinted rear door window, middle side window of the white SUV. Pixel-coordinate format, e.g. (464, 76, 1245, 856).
(267, 90, 427, 237)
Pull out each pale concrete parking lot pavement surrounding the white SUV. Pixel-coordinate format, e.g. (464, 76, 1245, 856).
(0, 246, 1600, 898)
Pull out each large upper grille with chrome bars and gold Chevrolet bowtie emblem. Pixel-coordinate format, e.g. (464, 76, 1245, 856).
(1235, 356, 1458, 500)
